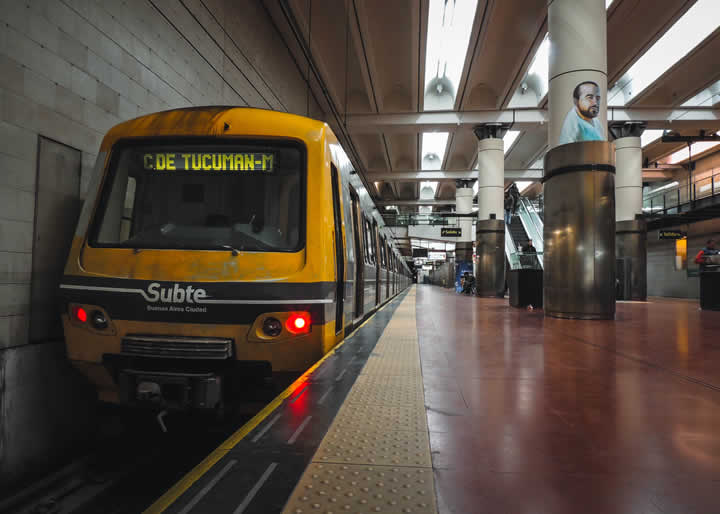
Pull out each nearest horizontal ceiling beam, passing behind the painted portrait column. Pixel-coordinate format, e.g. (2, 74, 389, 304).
(347, 107, 720, 134)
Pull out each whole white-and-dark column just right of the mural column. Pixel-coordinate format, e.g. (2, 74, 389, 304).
(611, 123, 647, 301)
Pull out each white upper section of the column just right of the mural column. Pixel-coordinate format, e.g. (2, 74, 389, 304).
(615, 136, 642, 221)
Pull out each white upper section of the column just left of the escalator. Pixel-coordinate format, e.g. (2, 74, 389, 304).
(478, 137, 505, 220)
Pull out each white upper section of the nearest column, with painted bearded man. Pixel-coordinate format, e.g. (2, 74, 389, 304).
(548, 0, 607, 149)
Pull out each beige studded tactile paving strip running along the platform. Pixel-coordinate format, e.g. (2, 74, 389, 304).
(283, 289, 437, 514)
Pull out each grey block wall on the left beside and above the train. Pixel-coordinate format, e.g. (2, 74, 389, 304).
(0, 0, 323, 490)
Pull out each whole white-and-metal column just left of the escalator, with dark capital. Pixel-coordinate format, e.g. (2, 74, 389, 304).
(475, 124, 507, 297)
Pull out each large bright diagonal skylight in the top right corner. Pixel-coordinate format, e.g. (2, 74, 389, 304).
(608, 0, 720, 105)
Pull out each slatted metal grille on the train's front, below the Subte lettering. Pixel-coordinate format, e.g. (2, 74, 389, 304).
(122, 336, 232, 359)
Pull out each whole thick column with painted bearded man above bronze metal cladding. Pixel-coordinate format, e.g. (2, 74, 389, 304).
(543, 0, 615, 319)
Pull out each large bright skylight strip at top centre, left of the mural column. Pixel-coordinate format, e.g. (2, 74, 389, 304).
(425, 0, 477, 110)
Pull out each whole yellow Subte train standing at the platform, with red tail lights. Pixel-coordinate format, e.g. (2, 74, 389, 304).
(60, 107, 411, 409)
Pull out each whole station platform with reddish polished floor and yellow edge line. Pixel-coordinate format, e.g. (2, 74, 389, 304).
(146, 285, 720, 514)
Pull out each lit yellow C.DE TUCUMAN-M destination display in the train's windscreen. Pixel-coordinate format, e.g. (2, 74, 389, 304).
(143, 152, 275, 173)
